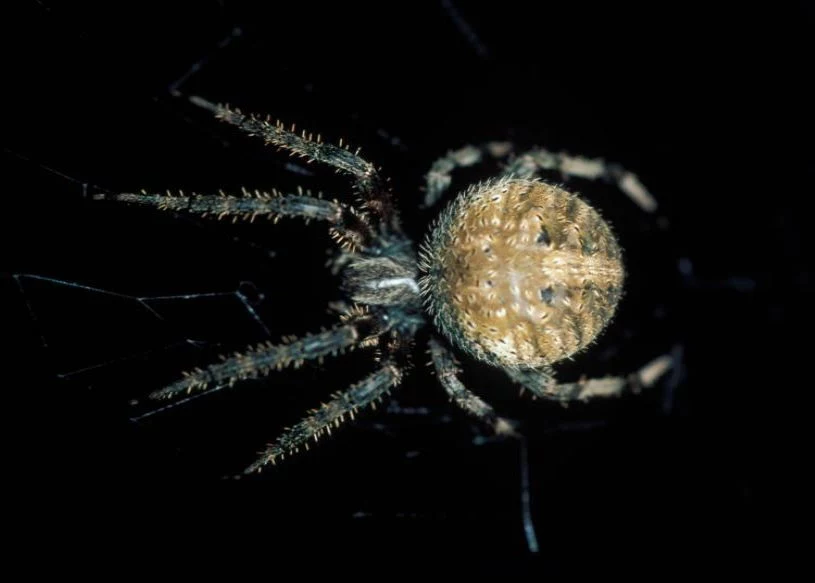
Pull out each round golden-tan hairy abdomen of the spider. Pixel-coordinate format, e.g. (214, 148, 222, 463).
(422, 179, 624, 368)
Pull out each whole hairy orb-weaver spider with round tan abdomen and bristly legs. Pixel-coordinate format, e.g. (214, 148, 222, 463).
(94, 96, 671, 474)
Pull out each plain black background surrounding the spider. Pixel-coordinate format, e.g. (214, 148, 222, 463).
(0, 1, 813, 571)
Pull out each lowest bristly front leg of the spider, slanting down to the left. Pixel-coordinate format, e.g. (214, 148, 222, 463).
(244, 362, 402, 474)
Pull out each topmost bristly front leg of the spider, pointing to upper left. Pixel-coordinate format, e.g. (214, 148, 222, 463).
(190, 96, 398, 225)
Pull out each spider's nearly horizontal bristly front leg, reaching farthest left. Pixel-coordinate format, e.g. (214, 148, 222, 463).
(93, 189, 373, 250)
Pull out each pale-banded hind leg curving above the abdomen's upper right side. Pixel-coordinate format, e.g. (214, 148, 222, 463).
(504, 148, 657, 213)
